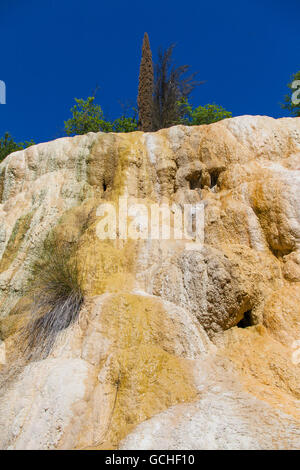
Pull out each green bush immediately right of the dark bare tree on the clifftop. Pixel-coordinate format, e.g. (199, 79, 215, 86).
(177, 98, 232, 126)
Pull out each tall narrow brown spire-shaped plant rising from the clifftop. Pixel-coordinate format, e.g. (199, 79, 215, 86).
(138, 33, 154, 132)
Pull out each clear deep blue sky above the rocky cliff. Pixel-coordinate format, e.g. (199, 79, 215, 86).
(0, 0, 300, 142)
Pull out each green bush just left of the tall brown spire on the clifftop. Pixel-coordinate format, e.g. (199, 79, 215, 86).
(65, 96, 137, 136)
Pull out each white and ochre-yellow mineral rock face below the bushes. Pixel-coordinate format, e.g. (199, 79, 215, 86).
(0, 116, 300, 449)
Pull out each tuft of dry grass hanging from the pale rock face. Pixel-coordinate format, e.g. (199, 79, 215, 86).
(21, 239, 83, 362)
